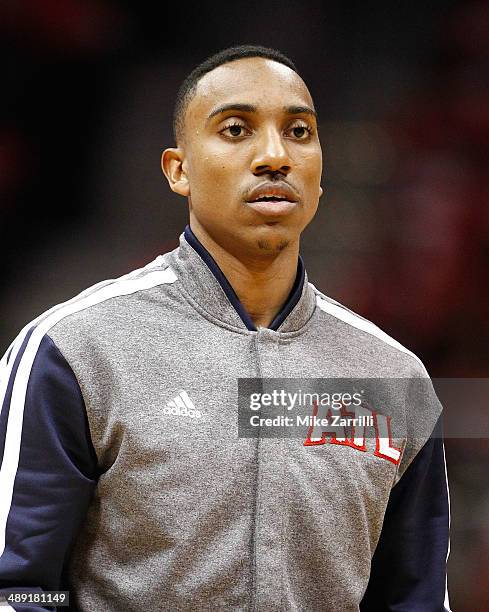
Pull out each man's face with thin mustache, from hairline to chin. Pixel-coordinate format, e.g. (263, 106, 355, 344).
(166, 57, 322, 256)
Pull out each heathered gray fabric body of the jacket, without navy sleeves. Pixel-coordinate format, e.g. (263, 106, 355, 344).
(49, 235, 438, 612)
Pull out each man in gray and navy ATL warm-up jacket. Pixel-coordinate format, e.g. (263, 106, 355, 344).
(0, 46, 449, 612)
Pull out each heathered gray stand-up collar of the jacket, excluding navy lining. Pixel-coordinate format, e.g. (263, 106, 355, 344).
(170, 225, 316, 332)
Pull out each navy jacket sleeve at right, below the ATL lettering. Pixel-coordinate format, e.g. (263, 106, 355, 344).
(360, 416, 450, 612)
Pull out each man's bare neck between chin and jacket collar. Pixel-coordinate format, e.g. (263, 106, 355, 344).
(187, 224, 299, 328)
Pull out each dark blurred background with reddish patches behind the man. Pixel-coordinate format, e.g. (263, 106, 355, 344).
(0, 0, 489, 612)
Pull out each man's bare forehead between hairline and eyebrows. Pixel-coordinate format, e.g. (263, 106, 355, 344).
(187, 57, 313, 121)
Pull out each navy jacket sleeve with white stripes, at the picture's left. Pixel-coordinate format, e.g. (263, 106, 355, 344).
(0, 328, 98, 612)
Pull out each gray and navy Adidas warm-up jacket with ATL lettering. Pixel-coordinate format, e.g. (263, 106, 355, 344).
(0, 227, 449, 612)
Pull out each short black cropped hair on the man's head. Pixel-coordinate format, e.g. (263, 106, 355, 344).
(173, 45, 299, 142)
